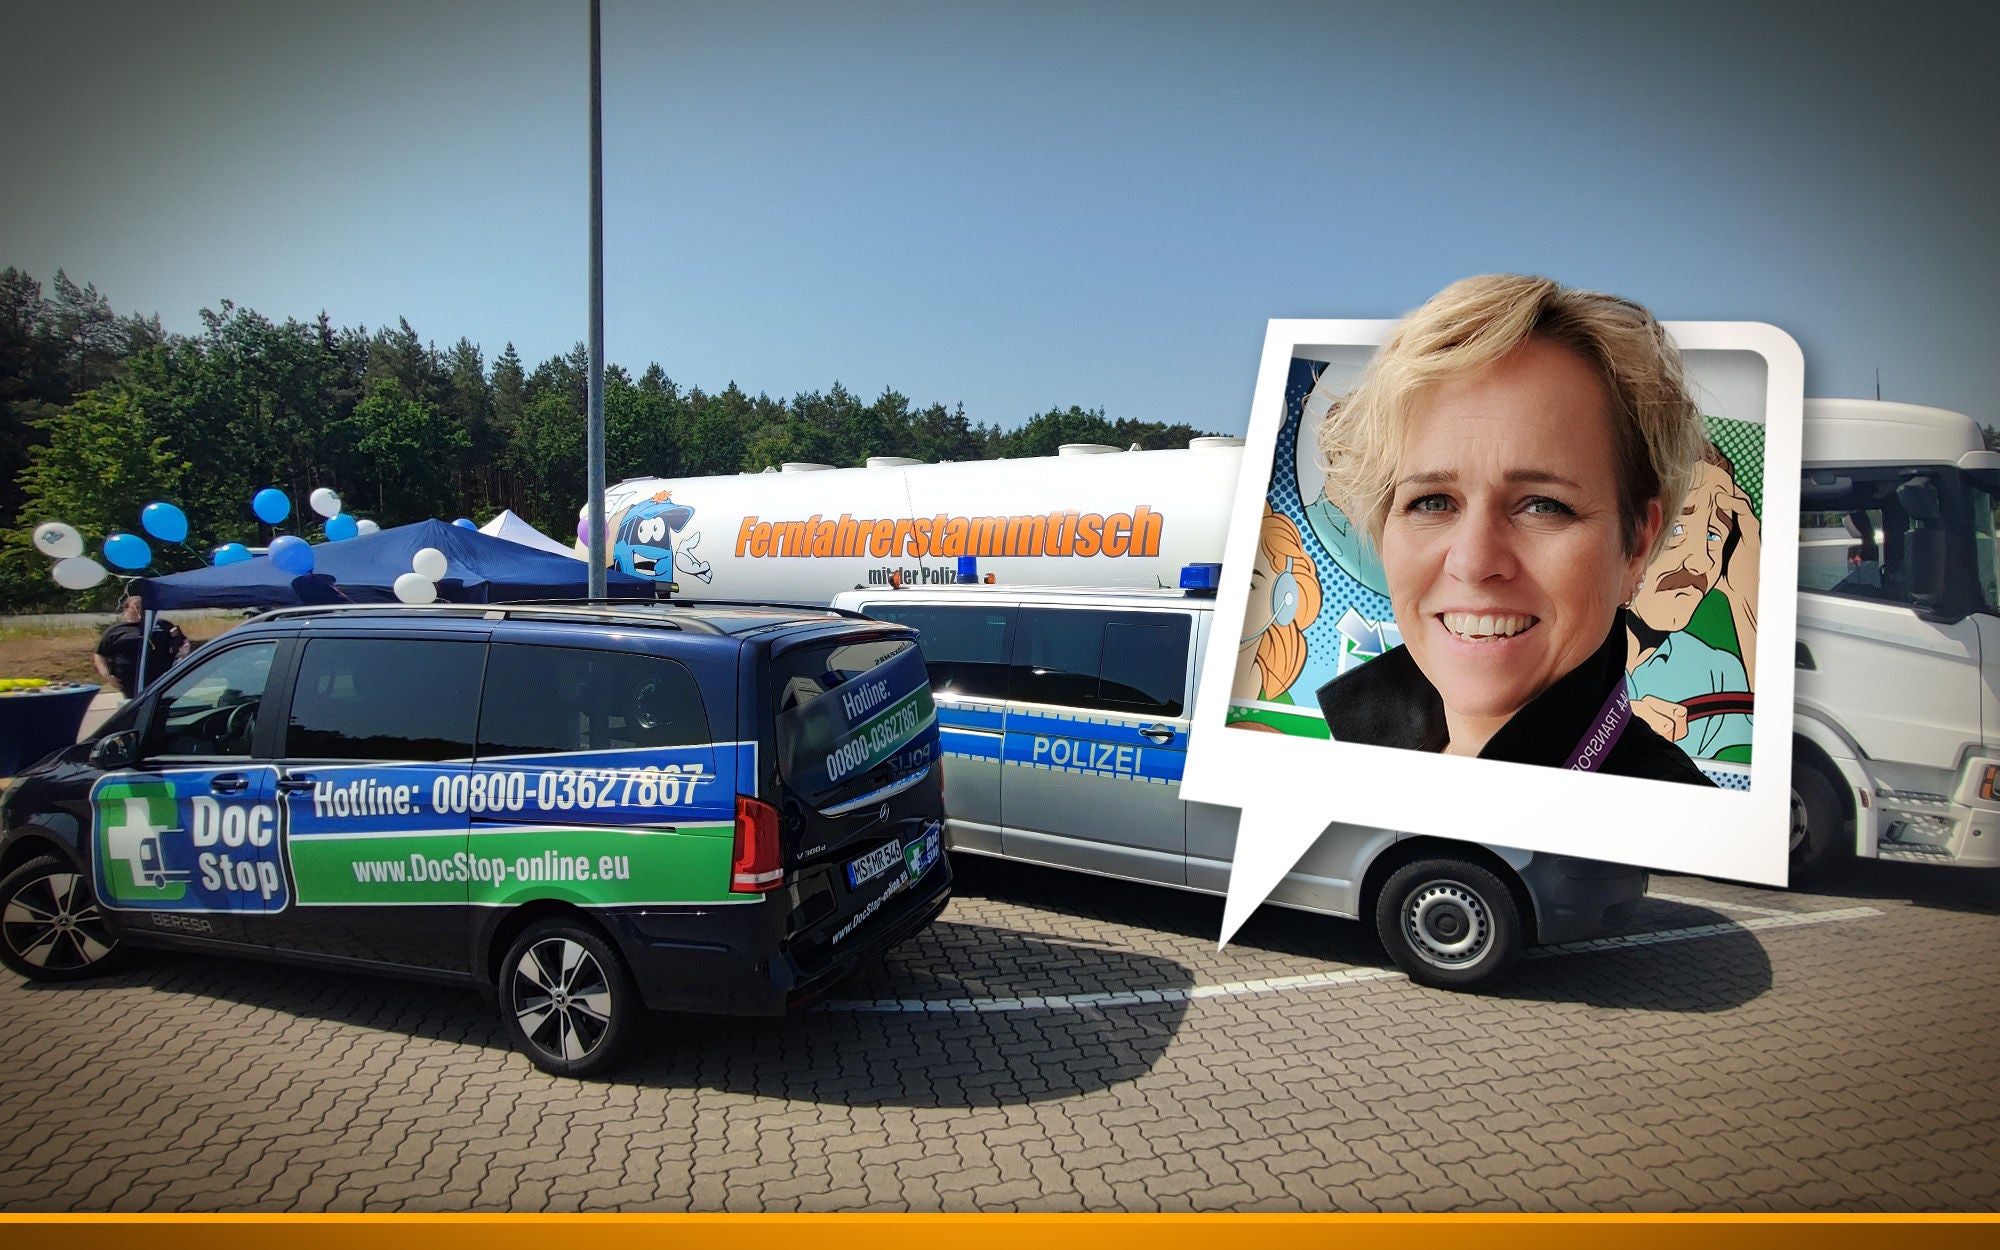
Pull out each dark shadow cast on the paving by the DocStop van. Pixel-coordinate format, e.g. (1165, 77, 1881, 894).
(22, 908, 1192, 1108)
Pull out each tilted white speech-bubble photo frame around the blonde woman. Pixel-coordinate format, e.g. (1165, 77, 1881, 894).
(1182, 320, 1804, 940)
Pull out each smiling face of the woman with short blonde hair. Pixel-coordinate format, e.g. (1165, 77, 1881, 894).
(1382, 340, 1660, 754)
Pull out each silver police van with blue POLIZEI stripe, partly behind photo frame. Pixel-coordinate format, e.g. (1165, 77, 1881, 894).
(834, 584, 1646, 986)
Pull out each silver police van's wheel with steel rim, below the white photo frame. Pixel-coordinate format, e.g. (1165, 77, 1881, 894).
(1376, 858, 1522, 990)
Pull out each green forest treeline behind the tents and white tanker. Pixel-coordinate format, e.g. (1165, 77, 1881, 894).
(0, 268, 1200, 612)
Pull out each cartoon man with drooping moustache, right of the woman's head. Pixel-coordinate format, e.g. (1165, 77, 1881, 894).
(1626, 444, 1764, 760)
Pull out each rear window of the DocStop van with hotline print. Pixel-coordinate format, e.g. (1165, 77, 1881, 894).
(772, 638, 938, 810)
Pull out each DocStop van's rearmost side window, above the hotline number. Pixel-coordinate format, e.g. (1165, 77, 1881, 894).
(480, 642, 710, 756)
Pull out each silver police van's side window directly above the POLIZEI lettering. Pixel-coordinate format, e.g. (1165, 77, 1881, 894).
(1008, 608, 1190, 716)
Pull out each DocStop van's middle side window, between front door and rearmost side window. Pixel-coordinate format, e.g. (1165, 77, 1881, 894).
(284, 638, 486, 760)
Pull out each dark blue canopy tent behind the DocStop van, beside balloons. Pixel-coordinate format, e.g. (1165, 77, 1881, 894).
(132, 520, 654, 614)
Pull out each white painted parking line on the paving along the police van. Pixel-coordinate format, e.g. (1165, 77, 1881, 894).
(820, 900, 1882, 1016)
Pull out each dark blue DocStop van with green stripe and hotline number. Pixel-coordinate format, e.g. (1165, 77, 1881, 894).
(0, 604, 950, 1076)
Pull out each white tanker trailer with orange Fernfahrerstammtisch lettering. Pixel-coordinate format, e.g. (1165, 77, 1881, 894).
(580, 438, 1242, 604)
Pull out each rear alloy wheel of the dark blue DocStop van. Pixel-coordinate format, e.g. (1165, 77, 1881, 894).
(498, 920, 644, 1076)
